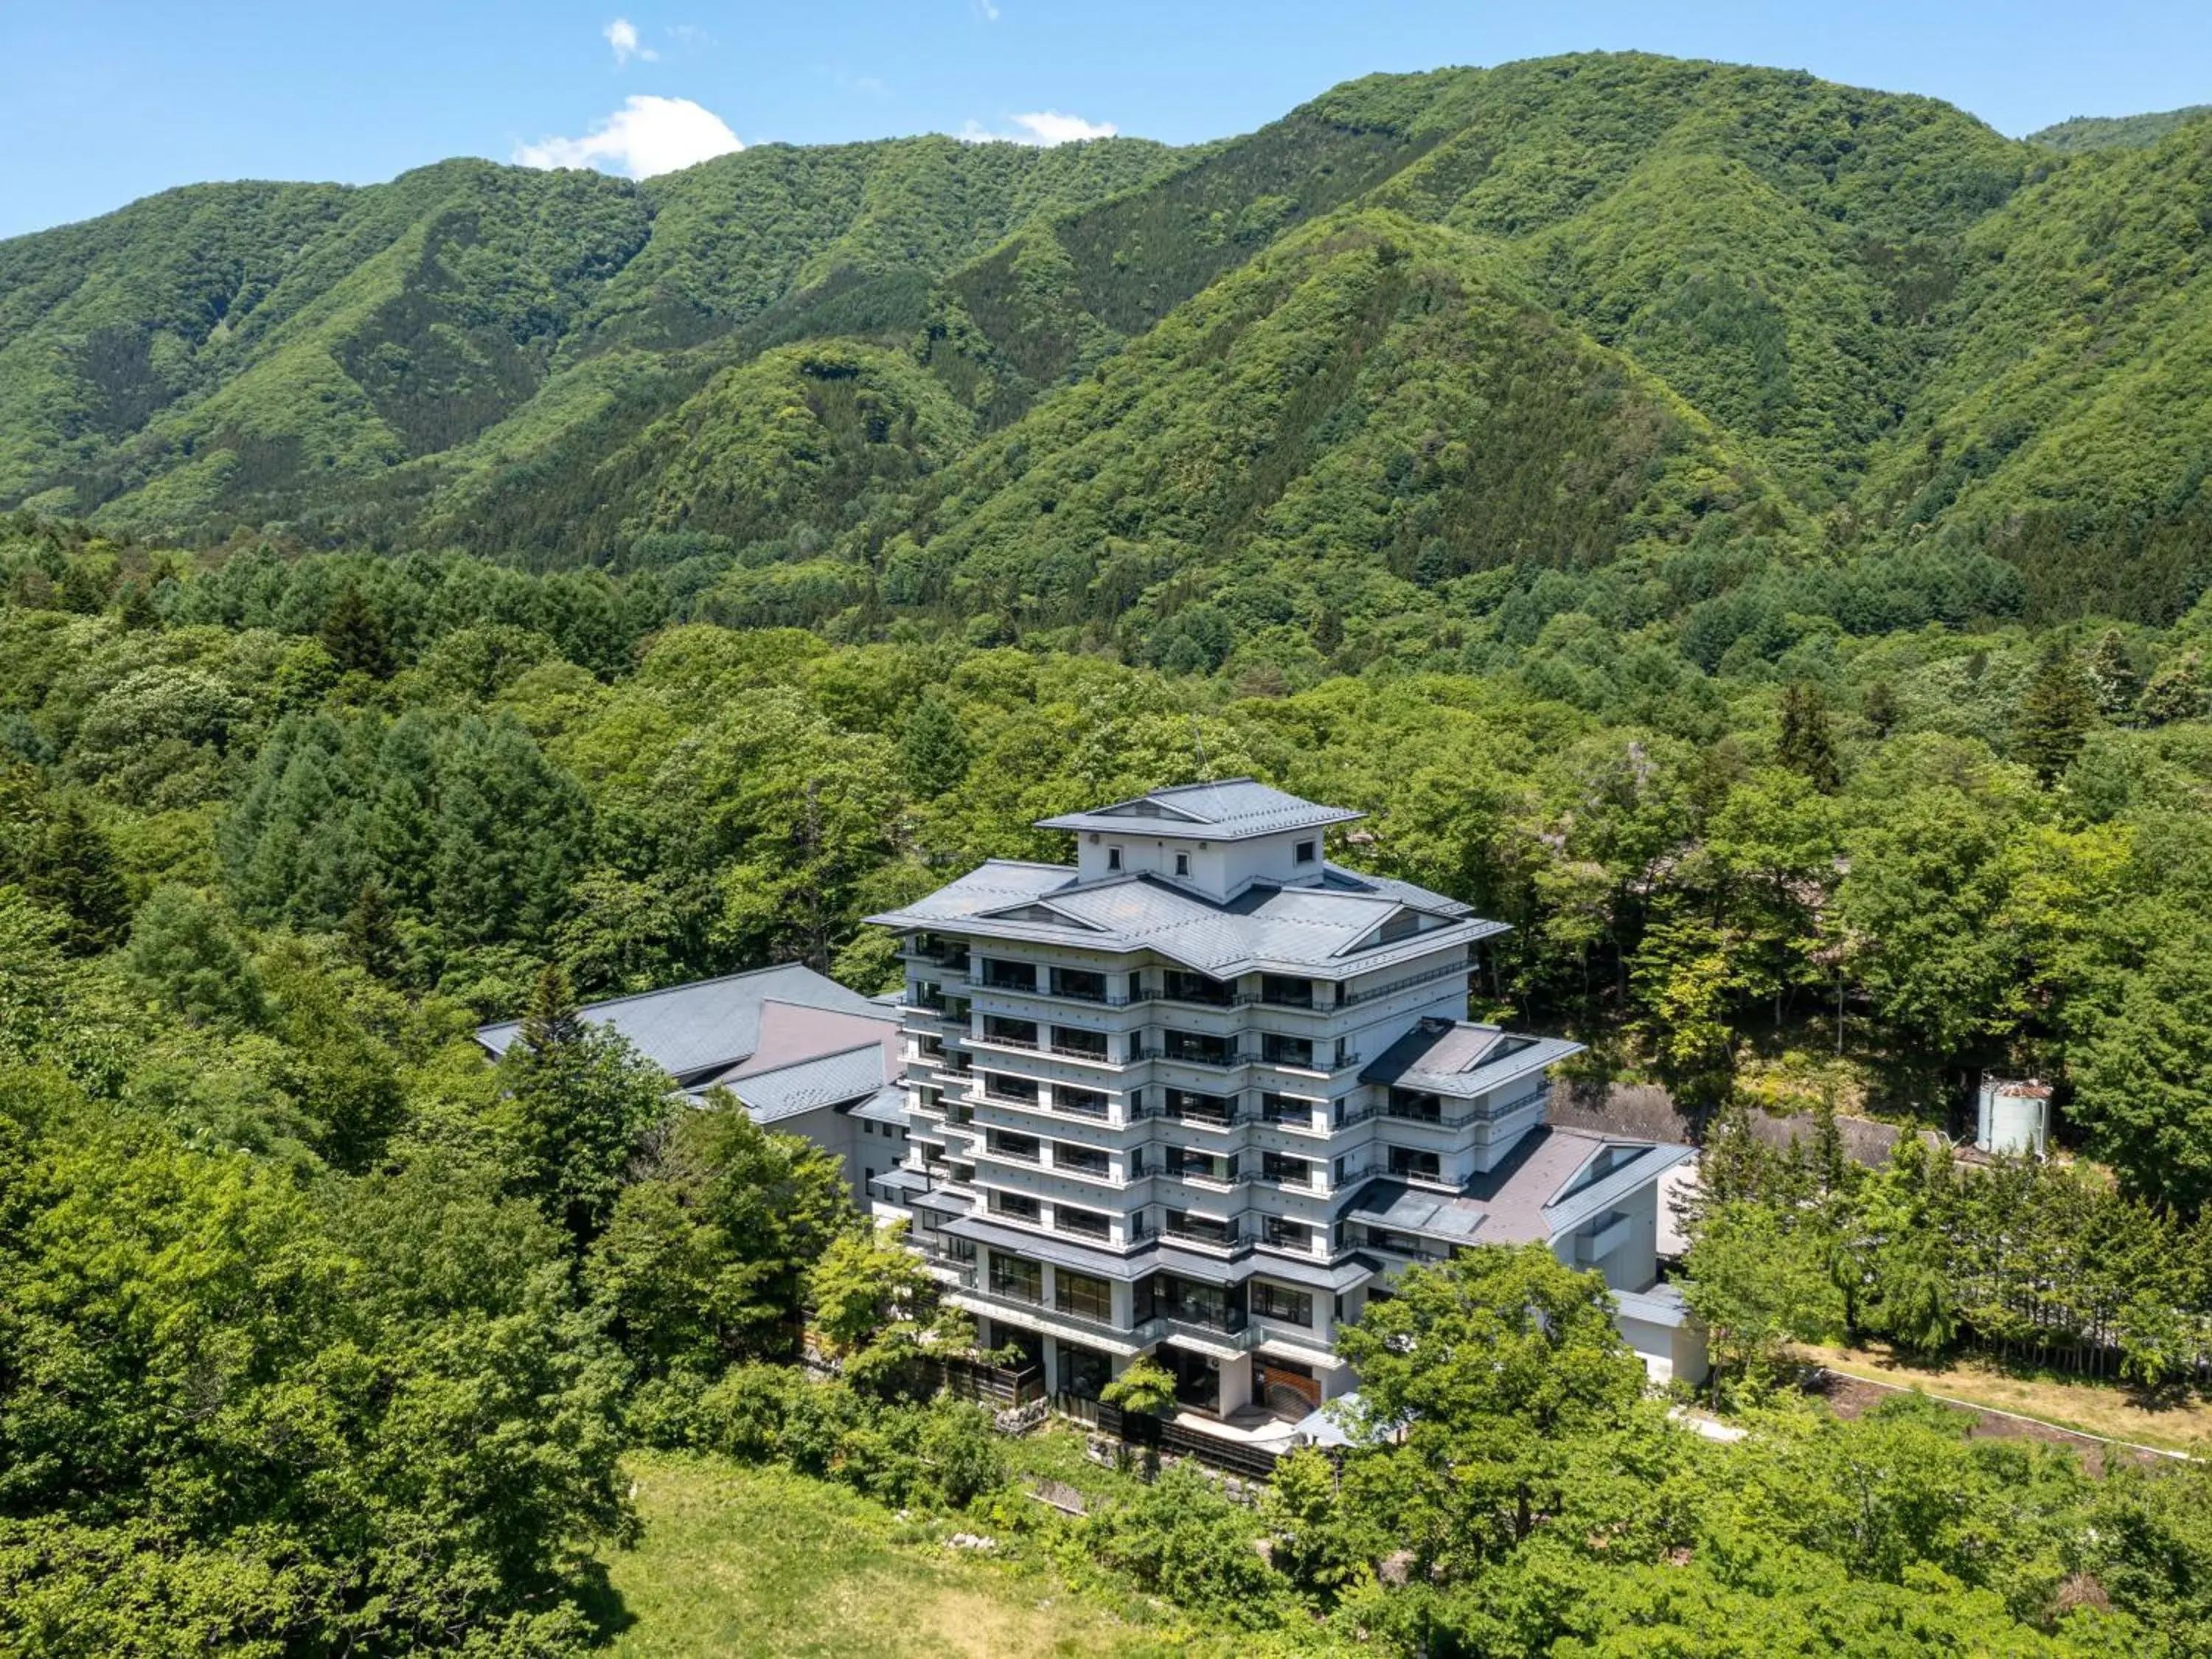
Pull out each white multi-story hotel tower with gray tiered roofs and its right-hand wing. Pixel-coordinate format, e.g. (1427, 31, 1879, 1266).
(872, 779, 1703, 1416)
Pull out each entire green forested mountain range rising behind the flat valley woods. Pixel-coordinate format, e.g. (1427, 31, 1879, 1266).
(13, 53, 2212, 637)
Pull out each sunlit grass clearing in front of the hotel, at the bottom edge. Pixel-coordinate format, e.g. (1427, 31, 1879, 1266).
(608, 1453, 1159, 1659)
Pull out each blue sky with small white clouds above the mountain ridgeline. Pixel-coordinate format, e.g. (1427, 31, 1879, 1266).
(0, 0, 2212, 234)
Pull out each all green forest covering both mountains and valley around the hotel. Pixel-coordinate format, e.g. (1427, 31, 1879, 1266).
(13, 45, 2212, 1659)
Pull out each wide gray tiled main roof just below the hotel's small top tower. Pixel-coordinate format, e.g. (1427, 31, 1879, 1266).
(869, 860, 1504, 978)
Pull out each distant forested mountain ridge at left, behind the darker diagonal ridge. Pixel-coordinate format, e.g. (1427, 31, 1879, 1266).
(0, 139, 1170, 540)
